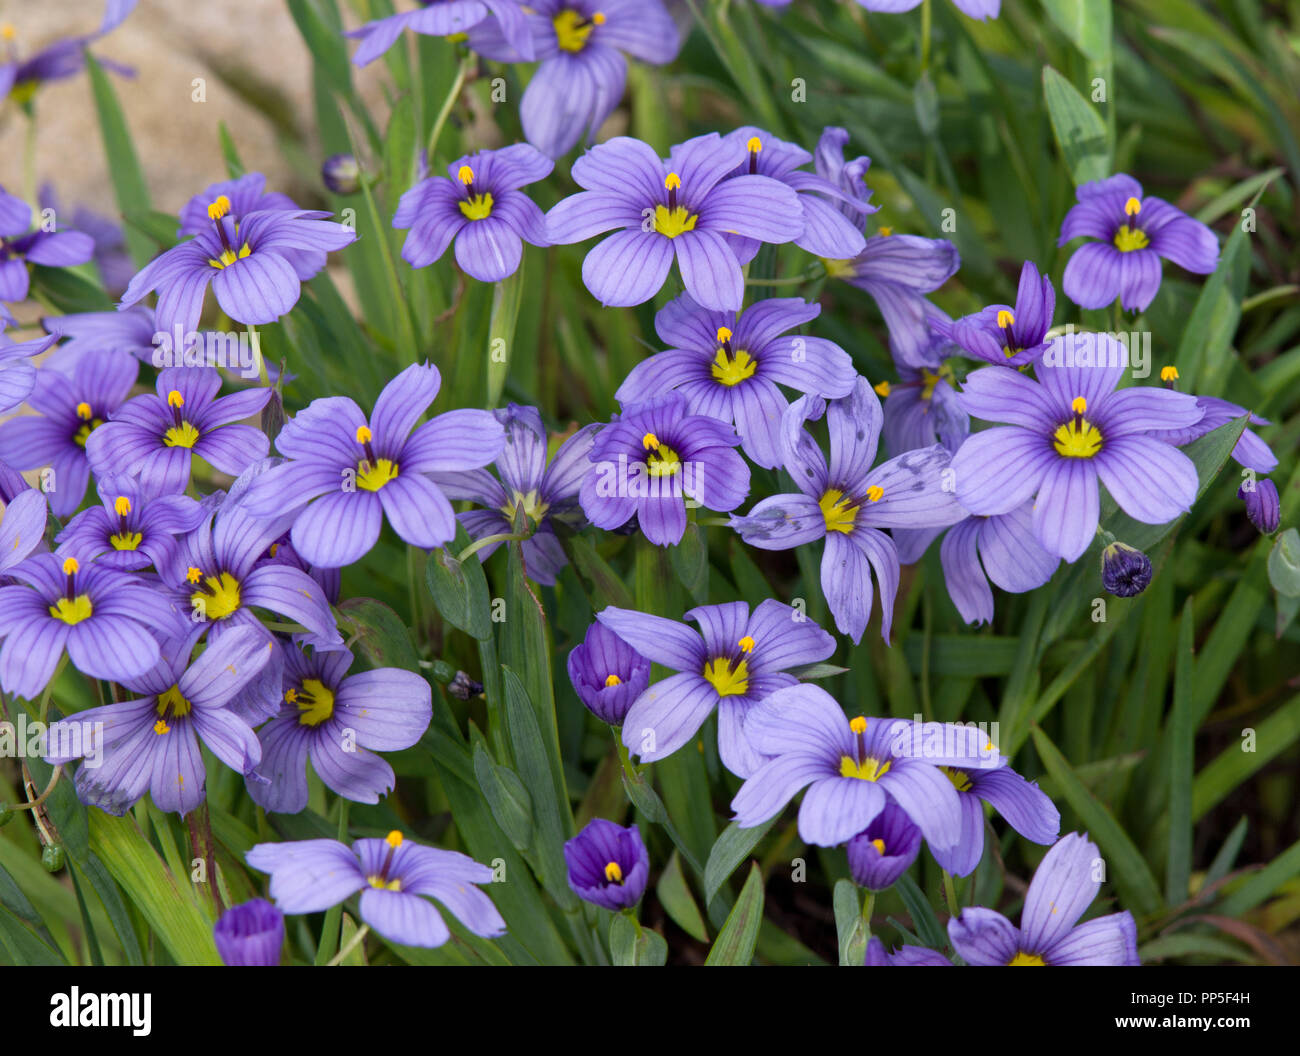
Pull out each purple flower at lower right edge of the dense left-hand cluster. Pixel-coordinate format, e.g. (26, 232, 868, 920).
(241, 649, 433, 814)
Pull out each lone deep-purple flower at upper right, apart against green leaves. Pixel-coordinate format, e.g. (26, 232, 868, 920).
(1057, 173, 1218, 312)
